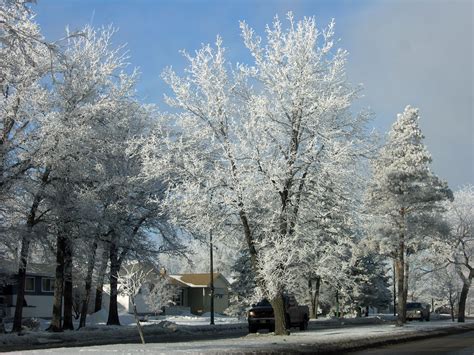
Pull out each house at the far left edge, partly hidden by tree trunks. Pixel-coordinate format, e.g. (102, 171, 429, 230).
(0, 261, 54, 318)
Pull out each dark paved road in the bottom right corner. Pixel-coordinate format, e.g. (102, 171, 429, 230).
(350, 331, 474, 355)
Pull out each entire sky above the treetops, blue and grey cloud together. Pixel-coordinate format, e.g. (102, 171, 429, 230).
(34, 0, 474, 188)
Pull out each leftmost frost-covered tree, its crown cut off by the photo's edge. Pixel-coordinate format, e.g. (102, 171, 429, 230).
(0, 0, 56, 331)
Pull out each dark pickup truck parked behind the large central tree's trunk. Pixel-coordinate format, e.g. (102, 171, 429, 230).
(248, 295, 309, 333)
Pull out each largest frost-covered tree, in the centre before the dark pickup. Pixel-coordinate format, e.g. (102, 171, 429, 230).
(143, 14, 367, 334)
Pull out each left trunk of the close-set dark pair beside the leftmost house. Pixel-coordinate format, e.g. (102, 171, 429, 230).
(48, 233, 66, 332)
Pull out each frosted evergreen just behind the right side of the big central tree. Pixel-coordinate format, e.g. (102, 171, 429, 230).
(296, 159, 364, 318)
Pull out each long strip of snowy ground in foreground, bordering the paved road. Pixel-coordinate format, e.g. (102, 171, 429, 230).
(8, 321, 474, 354)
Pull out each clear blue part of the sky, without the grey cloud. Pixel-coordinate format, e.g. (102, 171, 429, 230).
(35, 0, 369, 103)
